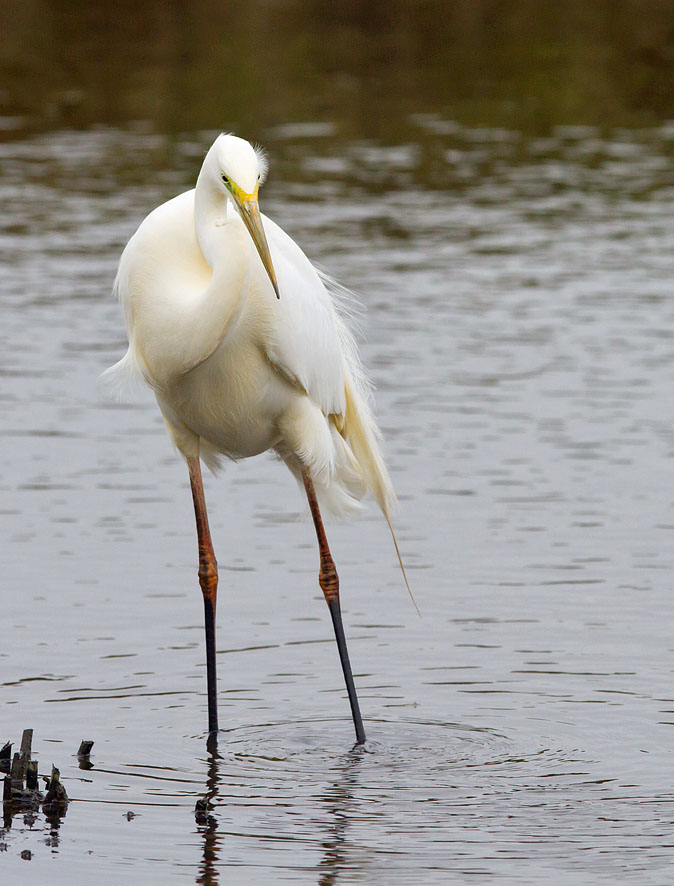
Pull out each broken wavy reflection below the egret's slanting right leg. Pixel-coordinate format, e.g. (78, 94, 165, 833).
(318, 744, 367, 886)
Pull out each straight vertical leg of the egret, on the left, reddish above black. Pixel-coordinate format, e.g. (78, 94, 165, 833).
(187, 455, 218, 735)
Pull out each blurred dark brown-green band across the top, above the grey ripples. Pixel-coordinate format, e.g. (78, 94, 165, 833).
(0, 0, 674, 143)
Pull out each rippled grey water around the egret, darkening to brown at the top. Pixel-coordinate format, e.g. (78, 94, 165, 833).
(0, 3, 674, 886)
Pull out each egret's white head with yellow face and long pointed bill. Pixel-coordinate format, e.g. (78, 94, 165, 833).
(209, 134, 281, 298)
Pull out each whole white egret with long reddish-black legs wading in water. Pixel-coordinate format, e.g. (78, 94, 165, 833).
(107, 134, 409, 743)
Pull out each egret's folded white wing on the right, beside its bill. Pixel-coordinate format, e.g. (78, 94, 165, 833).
(263, 217, 346, 415)
